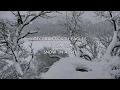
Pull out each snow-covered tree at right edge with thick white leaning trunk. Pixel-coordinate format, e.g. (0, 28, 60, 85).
(95, 11, 120, 58)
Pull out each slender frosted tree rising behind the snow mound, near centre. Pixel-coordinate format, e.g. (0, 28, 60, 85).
(62, 11, 85, 57)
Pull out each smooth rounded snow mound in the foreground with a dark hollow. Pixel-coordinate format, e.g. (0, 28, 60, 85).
(41, 57, 120, 79)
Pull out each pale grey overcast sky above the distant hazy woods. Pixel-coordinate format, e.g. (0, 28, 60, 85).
(0, 11, 103, 23)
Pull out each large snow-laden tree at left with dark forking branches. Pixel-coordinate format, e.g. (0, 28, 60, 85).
(0, 11, 52, 77)
